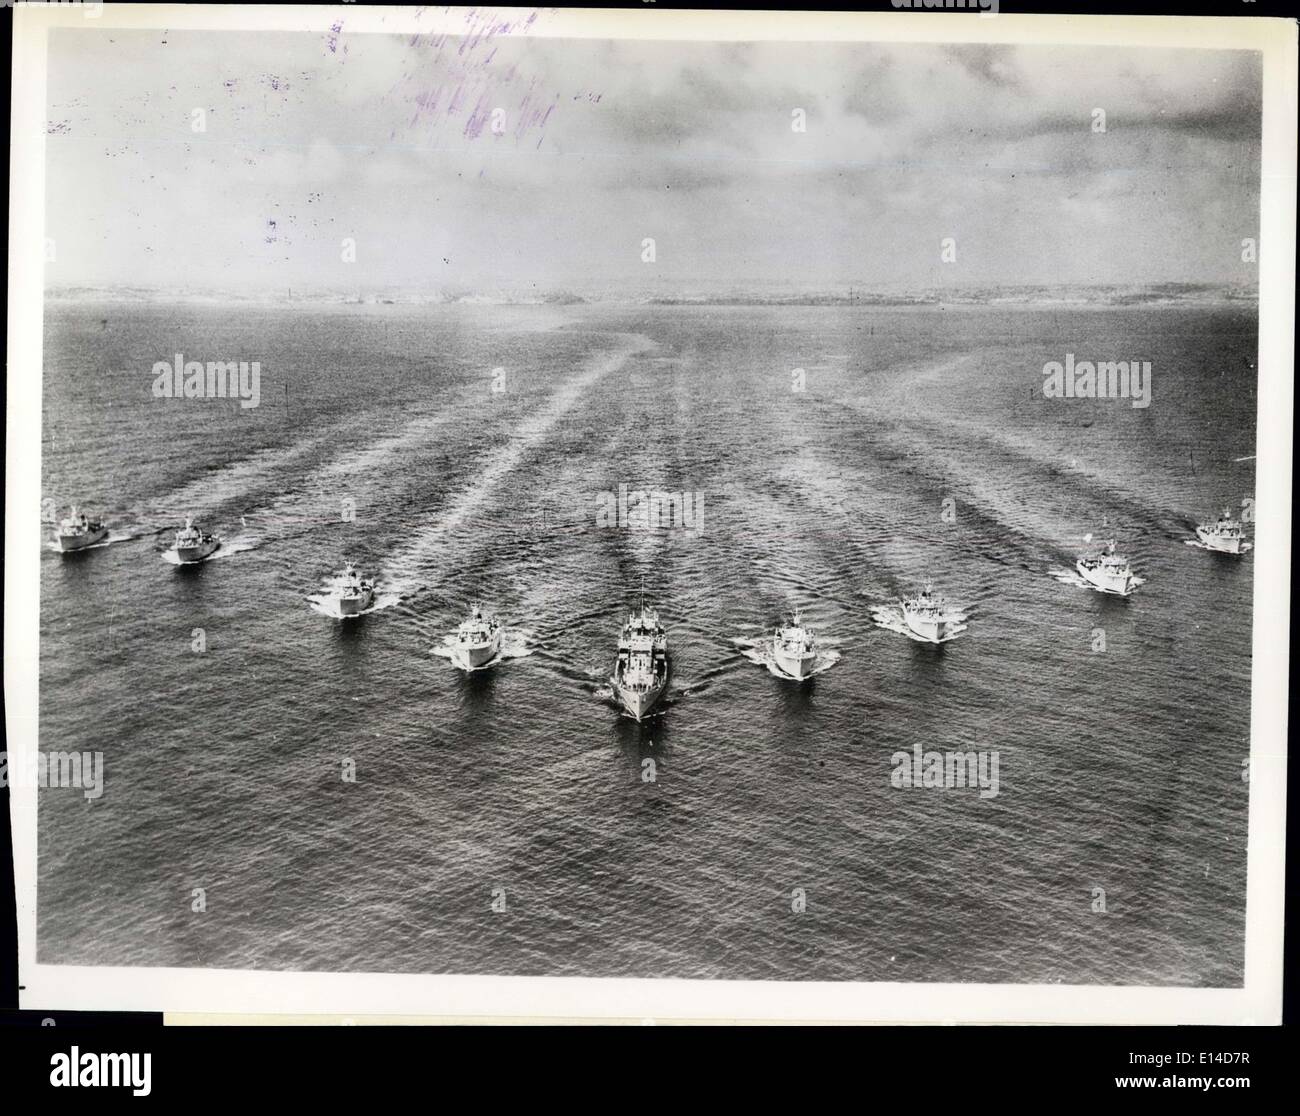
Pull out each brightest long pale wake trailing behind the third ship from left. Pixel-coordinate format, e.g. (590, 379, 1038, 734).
(384, 334, 655, 596)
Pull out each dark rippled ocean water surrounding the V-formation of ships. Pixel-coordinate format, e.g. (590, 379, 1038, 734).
(38, 302, 1257, 987)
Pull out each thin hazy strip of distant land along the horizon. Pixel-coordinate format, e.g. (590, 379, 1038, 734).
(46, 282, 1258, 307)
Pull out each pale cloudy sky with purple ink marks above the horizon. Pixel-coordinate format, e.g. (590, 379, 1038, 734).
(46, 25, 1261, 295)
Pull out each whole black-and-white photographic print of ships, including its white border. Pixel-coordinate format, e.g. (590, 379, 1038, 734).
(7, 5, 1294, 1022)
